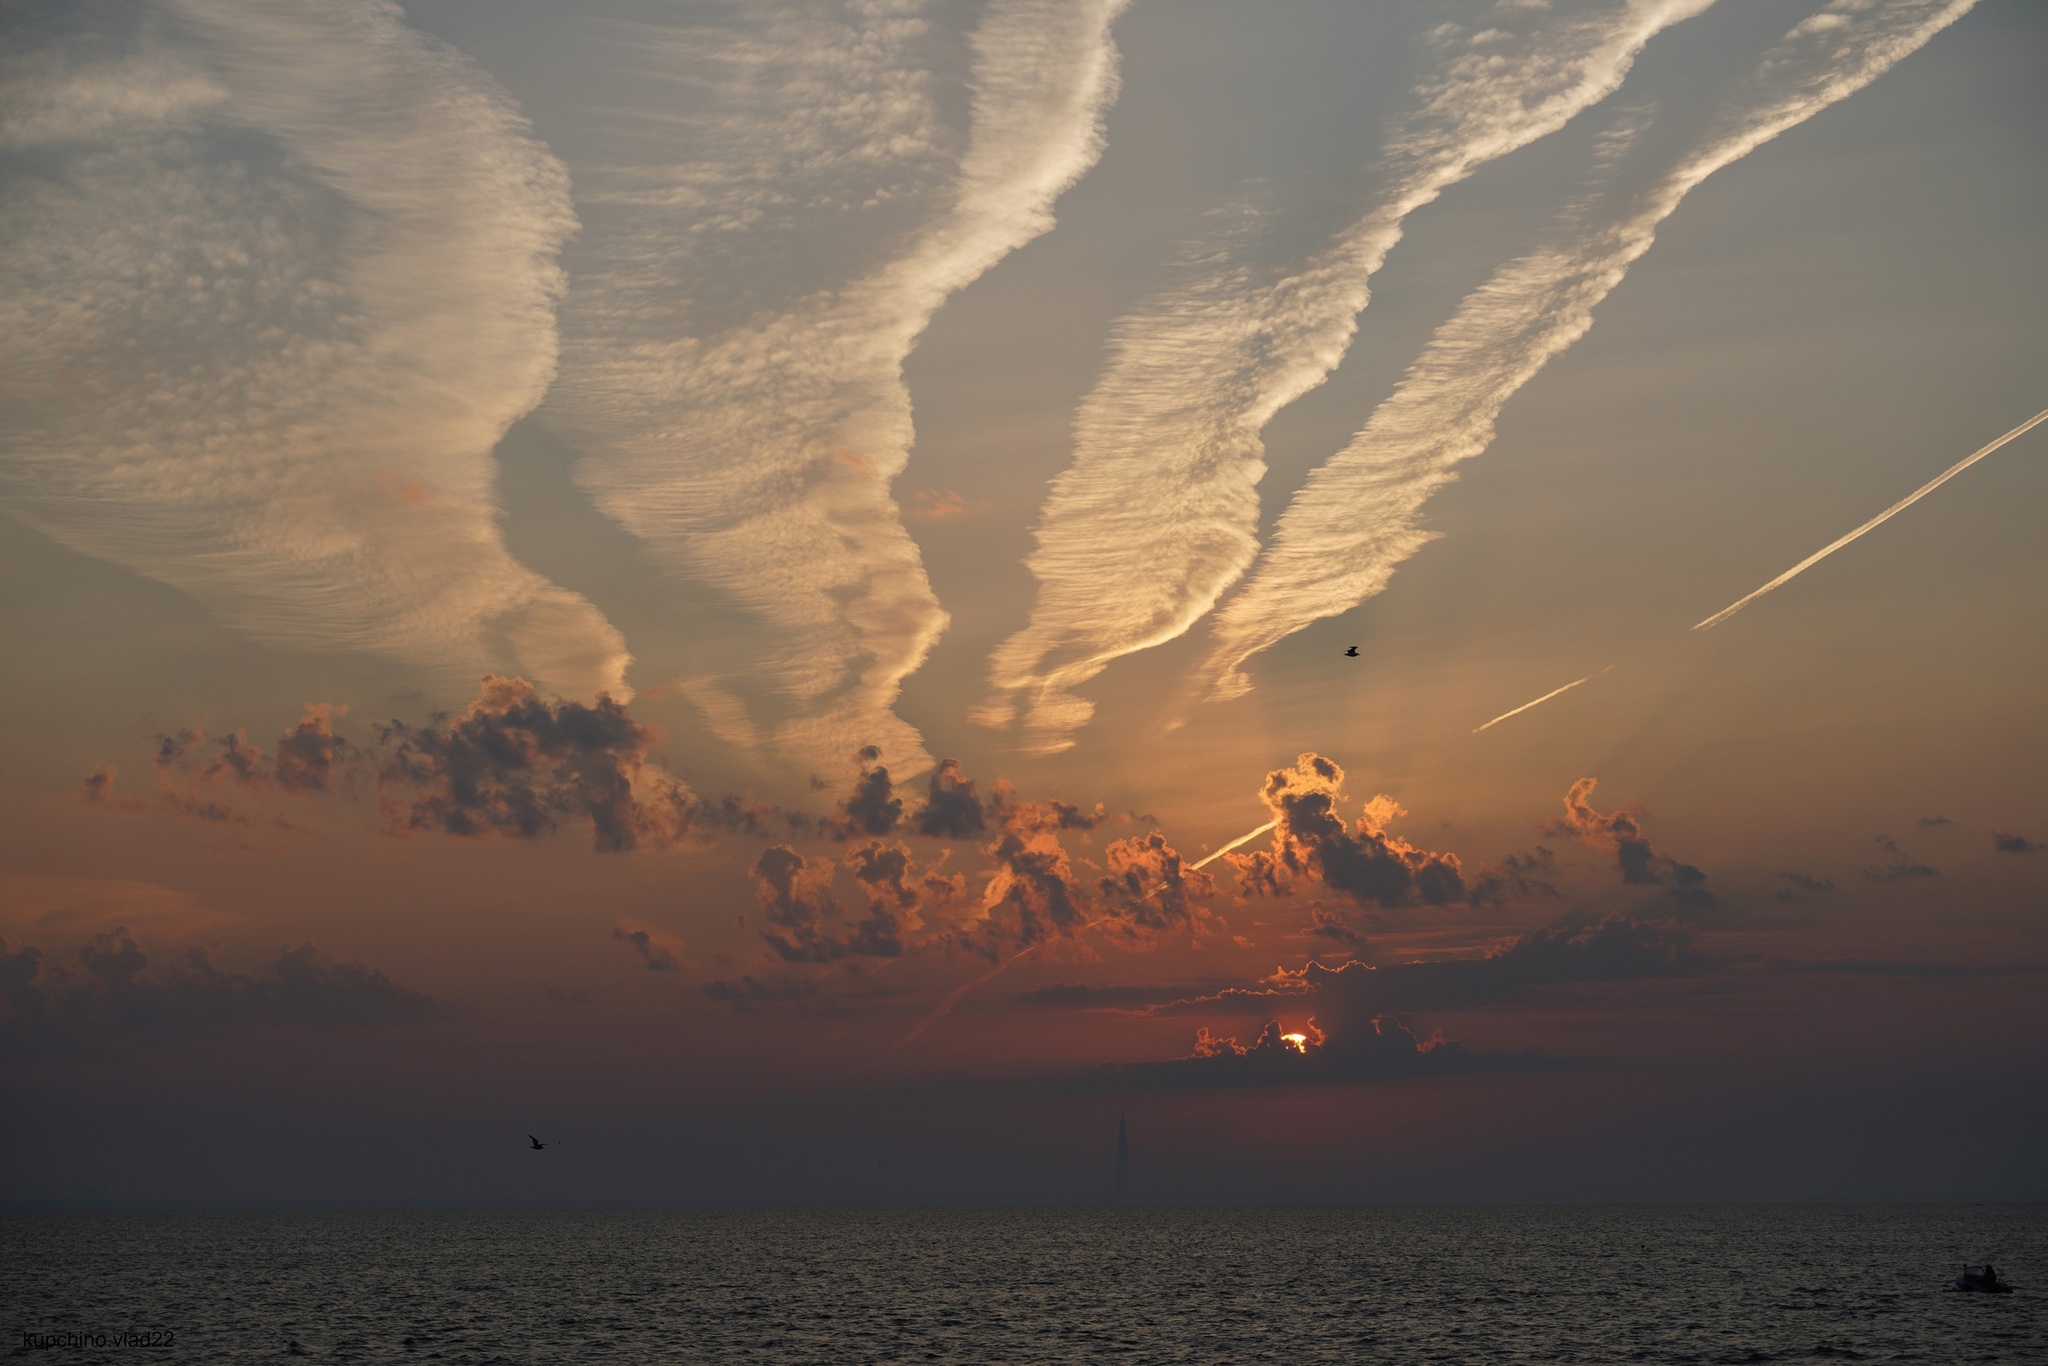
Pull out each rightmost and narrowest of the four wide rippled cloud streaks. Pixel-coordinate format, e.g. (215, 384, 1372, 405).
(1190, 0, 1974, 698)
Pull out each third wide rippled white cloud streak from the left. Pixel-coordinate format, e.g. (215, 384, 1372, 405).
(973, 0, 1712, 752)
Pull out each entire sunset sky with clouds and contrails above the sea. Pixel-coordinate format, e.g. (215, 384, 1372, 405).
(0, 0, 2048, 1204)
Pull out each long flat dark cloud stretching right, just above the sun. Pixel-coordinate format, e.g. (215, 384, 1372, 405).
(1151, 920, 1712, 1022)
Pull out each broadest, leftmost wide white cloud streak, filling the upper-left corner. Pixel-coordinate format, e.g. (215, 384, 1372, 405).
(0, 0, 627, 698)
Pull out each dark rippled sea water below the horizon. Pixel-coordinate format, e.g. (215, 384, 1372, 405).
(0, 1206, 2048, 1364)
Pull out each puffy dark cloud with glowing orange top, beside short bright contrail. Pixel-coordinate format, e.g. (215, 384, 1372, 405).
(1225, 754, 1464, 907)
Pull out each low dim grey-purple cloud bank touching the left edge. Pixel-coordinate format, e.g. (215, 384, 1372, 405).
(0, 928, 442, 1038)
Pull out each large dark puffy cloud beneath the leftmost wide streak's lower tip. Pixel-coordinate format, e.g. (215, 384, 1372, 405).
(377, 676, 770, 850)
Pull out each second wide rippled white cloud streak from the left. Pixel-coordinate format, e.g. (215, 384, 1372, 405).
(549, 0, 1124, 772)
